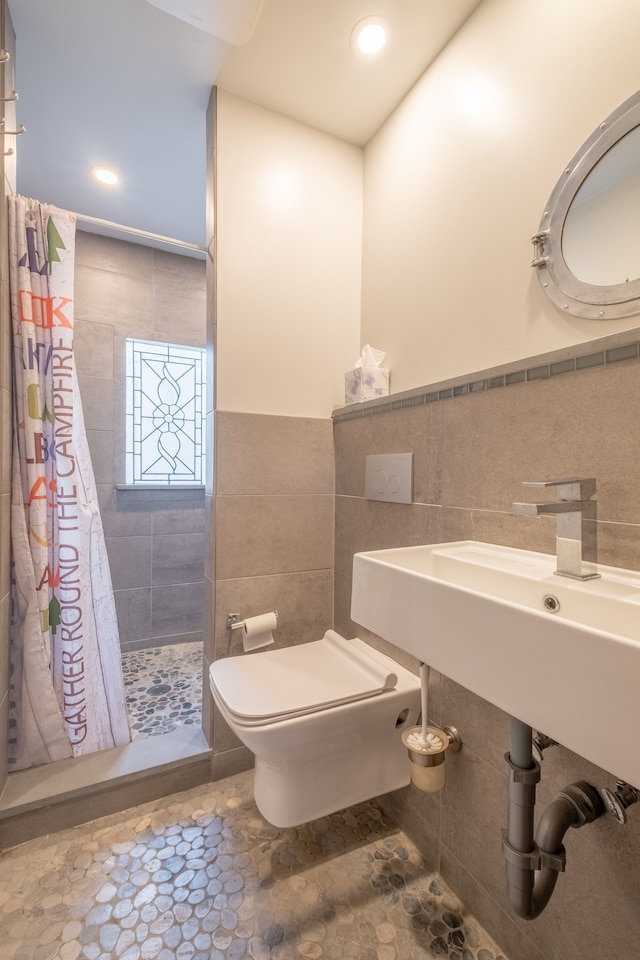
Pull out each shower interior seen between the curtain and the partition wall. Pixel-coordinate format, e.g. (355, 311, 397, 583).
(68, 231, 206, 739)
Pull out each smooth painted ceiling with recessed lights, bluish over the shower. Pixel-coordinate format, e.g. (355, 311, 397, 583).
(9, 0, 481, 251)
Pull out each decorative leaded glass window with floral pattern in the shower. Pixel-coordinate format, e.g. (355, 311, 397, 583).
(126, 339, 206, 486)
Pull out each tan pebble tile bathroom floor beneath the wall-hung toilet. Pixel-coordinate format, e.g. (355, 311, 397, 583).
(0, 772, 506, 960)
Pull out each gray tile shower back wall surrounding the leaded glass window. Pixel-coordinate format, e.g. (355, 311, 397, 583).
(75, 230, 206, 650)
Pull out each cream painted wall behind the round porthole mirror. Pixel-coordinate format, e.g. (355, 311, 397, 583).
(361, 0, 640, 392)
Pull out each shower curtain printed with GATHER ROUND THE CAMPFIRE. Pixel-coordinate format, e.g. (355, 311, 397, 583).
(9, 197, 130, 770)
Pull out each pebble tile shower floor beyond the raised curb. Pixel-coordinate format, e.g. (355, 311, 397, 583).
(122, 641, 202, 740)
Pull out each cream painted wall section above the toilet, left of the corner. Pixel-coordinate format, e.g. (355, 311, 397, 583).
(216, 89, 363, 417)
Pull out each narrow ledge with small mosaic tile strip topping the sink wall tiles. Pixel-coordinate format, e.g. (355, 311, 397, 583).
(332, 328, 640, 423)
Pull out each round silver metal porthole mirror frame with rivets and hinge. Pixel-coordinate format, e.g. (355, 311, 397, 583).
(531, 91, 640, 320)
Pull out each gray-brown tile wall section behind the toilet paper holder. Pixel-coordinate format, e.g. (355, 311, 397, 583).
(205, 411, 334, 761)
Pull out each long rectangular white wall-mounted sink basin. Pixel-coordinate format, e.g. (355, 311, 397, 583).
(351, 540, 640, 787)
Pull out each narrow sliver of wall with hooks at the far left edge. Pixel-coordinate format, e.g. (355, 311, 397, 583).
(0, 0, 16, 791)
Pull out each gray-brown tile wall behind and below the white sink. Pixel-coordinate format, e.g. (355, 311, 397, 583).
(334, 360, 640, 960)
